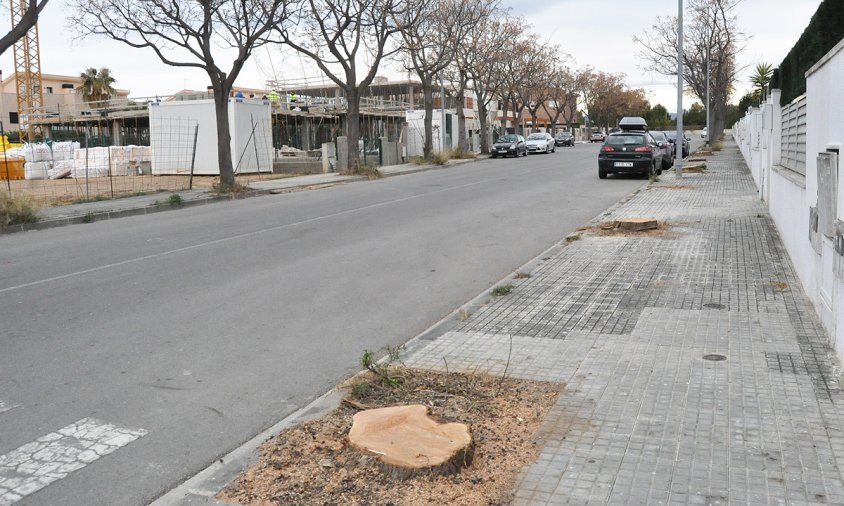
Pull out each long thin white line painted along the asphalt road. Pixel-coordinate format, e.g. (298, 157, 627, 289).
(0, 179, 491, 293)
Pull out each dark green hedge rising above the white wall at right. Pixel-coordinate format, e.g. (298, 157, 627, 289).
(771, 0, 844, 105)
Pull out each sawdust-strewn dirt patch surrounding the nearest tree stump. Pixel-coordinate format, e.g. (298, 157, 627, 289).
(217, 367, 563, 506)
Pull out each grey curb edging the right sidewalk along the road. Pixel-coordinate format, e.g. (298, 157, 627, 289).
(150, 177, 648, 506)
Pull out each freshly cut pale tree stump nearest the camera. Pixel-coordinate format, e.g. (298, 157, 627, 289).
(349, 404, 474, 479)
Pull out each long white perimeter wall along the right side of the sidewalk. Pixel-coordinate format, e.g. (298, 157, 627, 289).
(733, 37, 844, 360)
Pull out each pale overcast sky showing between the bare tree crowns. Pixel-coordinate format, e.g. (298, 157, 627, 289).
(0, 0, 821, 112)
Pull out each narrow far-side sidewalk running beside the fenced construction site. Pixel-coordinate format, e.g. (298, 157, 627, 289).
(0, 159, 474, 233)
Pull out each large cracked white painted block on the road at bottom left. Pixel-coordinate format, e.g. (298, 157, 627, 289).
(0, 418, 147, 506)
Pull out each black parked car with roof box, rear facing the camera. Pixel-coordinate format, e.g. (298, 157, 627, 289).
(598, 118, 662, 179)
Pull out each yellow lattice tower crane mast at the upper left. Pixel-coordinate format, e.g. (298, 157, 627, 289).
(9, 0, 44, 142)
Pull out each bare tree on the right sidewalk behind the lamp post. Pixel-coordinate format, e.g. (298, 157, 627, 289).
(634, 0, 745, 139)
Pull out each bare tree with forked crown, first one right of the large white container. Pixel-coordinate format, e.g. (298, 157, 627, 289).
(278, 0, 416, 172)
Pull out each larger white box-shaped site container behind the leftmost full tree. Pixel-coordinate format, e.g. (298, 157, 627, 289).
(149, 98, 273, 175)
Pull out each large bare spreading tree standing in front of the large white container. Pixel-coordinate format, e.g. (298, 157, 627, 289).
(70, 0, 287, 191)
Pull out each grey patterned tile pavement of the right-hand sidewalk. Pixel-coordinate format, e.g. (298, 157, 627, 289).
(407, 142, 844, 505)
